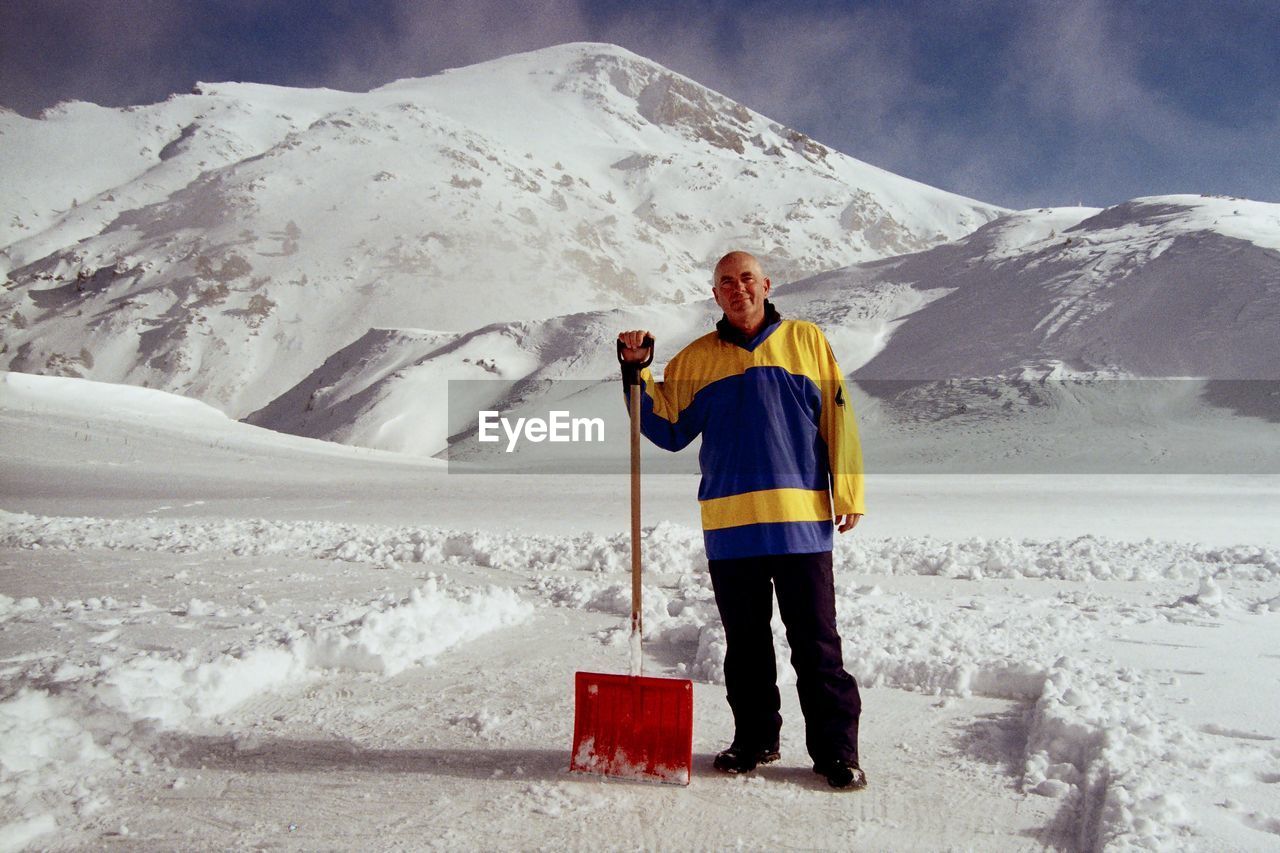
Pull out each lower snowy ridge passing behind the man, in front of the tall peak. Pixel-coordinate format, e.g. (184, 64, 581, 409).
(250, 196, 1280, 470)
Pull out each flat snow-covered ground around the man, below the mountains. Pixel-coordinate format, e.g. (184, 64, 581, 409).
(0, 375, 1280, 849)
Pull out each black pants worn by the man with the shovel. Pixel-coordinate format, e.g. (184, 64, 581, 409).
(709, 551, 863, 762)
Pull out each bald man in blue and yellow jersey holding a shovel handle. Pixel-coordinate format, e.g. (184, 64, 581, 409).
(618, 252, 867, 788)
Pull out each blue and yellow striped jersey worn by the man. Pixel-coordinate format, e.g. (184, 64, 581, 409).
(640, 312, 864, 560)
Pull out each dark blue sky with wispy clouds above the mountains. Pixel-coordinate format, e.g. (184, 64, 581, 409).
(0, 0, 1280, 209)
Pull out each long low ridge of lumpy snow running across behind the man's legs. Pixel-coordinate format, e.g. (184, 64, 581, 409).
(0, 511, 1280, 580)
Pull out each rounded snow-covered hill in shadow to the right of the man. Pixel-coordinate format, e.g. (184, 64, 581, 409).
(794, 196, 1280, 473)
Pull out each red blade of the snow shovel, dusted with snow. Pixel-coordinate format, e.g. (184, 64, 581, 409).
(570, 672, 694, 785)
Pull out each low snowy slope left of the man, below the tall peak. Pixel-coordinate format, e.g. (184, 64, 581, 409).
(247, 302, 716, 459)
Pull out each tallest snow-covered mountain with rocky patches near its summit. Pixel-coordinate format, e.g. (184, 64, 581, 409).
(0, 44, 1000, 416)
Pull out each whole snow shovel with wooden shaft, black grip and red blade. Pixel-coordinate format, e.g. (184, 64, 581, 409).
(570, 338, 694, 785)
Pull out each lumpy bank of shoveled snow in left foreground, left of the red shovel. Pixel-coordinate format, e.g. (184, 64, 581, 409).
(0, 568, 532, 849)
